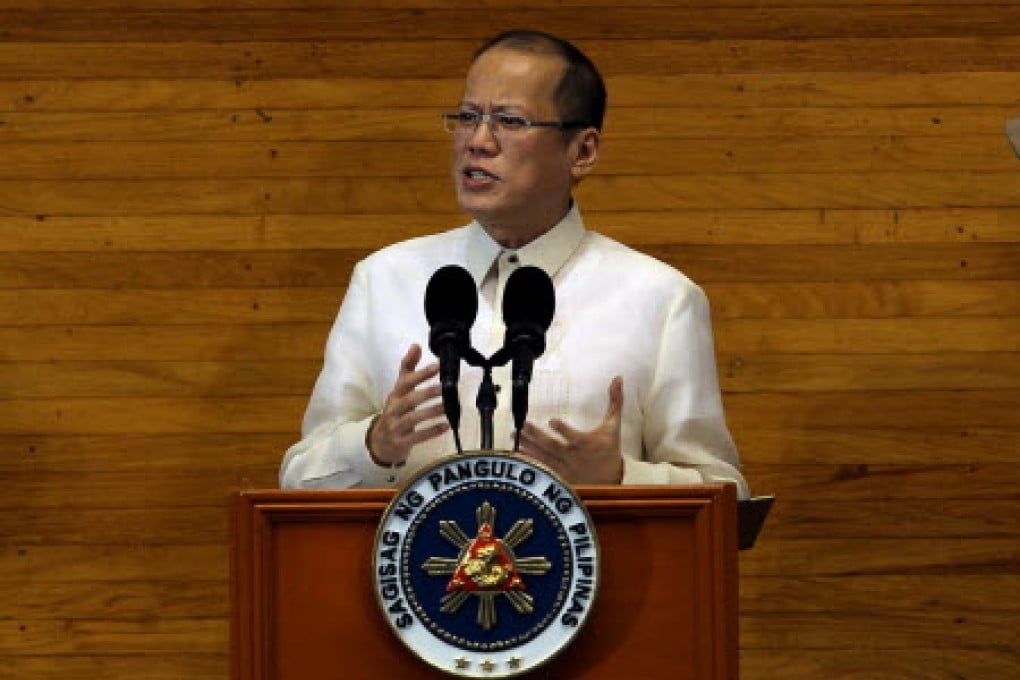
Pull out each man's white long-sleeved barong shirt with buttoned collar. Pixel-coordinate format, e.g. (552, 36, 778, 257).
(279, 204, 748, 498)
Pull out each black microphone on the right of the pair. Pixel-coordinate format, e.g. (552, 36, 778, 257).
(503, 266, 556, 451)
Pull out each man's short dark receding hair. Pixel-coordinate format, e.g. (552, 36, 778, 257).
(471, 29, 606, 130)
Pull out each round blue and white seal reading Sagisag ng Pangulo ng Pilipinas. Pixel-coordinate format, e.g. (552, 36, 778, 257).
(372, 453, 599, 678)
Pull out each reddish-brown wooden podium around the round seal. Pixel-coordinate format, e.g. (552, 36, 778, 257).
(231, 484, 737, 680)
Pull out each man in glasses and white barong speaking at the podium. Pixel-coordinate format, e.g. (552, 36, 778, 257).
(281, 31, 748, 498)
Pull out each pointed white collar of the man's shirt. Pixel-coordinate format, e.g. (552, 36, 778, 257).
(467, 202, 584, 286)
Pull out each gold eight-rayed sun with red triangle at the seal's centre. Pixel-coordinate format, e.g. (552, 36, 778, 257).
(421, 501, 552, 630)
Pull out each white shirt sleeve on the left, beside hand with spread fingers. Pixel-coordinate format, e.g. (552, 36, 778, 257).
(279, 263, 408, 488)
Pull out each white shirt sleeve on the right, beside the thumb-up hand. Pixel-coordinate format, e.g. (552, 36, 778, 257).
(623, 281, 749, 499)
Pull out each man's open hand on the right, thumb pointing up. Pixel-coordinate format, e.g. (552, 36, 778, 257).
(520, 375, 623, 484)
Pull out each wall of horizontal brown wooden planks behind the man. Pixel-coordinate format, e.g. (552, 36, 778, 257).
(0, 0, 1020, 680)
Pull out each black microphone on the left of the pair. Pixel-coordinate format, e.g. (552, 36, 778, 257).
(425, 264, 478, 453)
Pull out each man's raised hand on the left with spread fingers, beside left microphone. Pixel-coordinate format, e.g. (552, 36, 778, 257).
(368, 345, 450, 465)
